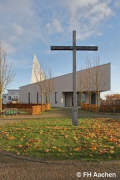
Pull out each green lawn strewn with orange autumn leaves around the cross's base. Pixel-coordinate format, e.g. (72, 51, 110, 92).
(0, 118, 120, 160)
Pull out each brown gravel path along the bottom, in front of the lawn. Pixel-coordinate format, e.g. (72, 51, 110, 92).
(0, 152, 120, 180)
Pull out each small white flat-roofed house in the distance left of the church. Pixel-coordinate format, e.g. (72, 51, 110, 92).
(2, 89, 19, 104)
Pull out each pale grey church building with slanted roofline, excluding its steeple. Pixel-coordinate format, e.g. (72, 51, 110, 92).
(20, 54, 111, 107)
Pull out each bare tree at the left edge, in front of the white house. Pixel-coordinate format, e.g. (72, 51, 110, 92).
(0, 42, 15, 112)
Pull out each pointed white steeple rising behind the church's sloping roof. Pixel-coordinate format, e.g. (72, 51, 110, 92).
(31, 54, 45, 84)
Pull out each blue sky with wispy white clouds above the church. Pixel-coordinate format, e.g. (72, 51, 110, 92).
(0, 0, 120, 98)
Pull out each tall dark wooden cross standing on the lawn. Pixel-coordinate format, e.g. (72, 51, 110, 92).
(51, 31, 98, 125)
